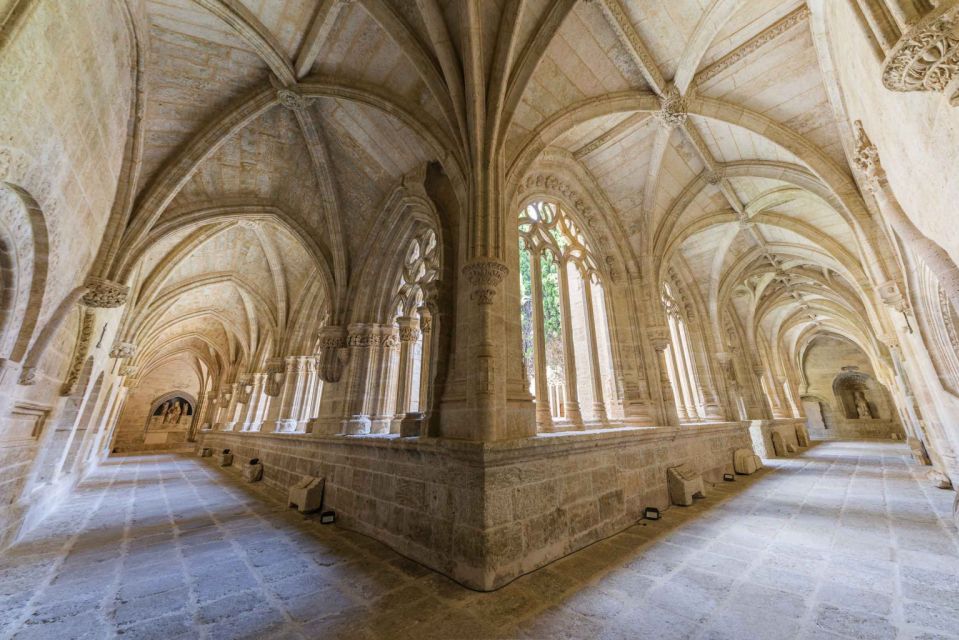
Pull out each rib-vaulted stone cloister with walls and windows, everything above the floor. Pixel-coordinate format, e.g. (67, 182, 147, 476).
(0, 0, 959, 636)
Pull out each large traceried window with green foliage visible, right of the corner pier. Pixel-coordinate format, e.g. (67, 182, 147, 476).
(518, 201, 612, 430)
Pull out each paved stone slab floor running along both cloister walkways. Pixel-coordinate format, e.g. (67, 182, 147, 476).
(0, 442, 959, 640)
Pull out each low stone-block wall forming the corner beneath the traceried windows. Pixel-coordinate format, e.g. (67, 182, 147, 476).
(198, 423, 750, 590)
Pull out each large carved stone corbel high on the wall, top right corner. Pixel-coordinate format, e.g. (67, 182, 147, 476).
(882, 2, 959, 106)
